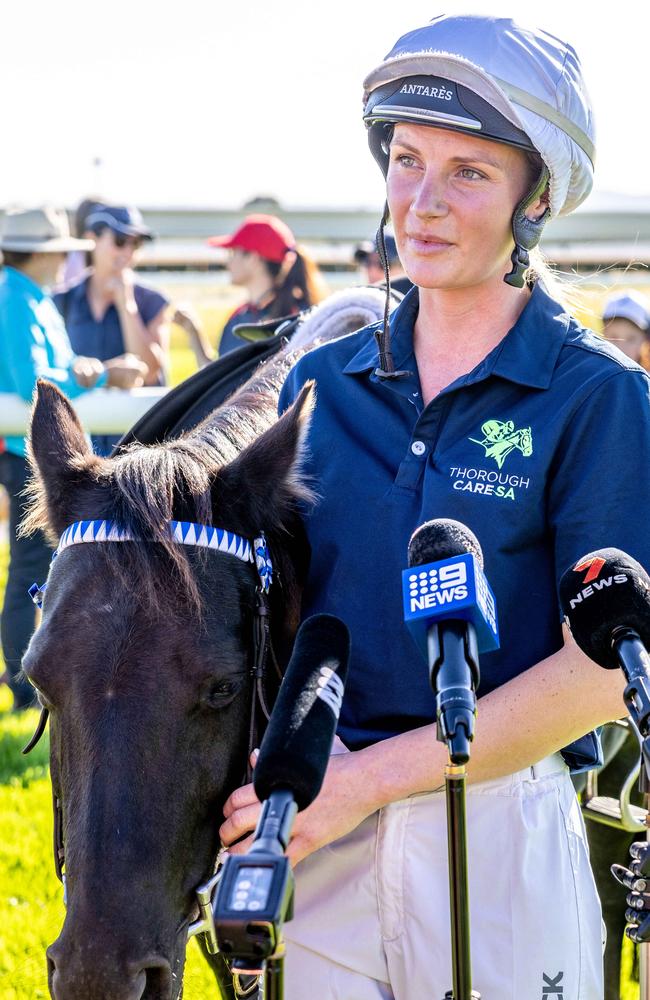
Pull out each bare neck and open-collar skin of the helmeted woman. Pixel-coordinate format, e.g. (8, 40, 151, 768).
(413, 281, 530, 404)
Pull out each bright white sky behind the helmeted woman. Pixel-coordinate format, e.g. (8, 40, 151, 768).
(0, 0, 650, 209)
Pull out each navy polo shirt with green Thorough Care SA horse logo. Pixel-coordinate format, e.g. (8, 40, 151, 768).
(280, 285, 650, 764)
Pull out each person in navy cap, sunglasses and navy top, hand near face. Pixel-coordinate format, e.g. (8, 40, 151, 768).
(54, 205, 169, 455)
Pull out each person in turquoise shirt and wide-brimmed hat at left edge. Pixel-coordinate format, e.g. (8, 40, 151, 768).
(0, 207, 145, 710)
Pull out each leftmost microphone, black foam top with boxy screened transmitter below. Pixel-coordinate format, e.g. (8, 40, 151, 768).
(214, 615, 350, 975)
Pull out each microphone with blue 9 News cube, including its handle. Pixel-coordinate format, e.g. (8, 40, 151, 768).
(402, 518, 499, 764)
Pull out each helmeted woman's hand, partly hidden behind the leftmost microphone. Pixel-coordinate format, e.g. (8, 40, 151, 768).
(219, 751, 378, 865)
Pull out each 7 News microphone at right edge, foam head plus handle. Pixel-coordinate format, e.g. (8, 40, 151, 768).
(560, 549, 650, 736)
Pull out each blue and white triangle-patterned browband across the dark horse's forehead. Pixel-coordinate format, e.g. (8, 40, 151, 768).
(29, 521, 273, 608)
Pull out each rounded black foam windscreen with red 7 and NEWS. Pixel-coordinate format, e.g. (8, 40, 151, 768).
(560, 549, 650, 670)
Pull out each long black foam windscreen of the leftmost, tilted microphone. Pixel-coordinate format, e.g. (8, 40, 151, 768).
(253, 615, 350, 810)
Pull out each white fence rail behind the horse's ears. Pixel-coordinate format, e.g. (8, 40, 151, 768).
(0, 386, 169, 437)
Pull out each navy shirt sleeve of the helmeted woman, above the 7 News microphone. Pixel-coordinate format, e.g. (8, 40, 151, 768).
(548, 369, 650, 582)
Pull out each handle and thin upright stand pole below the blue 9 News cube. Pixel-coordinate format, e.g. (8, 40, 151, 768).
(427, 621, 481, 1000)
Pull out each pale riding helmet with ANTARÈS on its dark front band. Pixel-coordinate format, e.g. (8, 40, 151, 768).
(364, 15, 595, 216)
